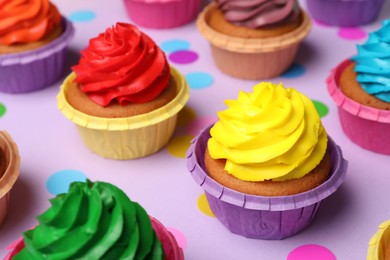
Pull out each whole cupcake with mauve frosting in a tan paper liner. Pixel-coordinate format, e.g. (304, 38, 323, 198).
(197, 0, 311, 80)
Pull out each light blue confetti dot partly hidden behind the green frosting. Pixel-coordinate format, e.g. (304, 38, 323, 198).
(46, 170, 87, 195)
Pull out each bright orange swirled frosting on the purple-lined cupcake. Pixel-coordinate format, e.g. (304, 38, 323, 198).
(0, 0, 61, 45)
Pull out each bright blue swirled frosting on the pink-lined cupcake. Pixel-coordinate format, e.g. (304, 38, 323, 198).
(352, 20, 390, 102)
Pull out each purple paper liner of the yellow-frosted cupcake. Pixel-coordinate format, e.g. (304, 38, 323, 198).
(187, 127, 347, 239)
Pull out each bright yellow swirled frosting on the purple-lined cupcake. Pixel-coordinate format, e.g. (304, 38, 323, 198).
(208, 82, 328, 181)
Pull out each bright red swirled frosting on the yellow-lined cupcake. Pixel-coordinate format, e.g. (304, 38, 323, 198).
(72, 23, 170, 107)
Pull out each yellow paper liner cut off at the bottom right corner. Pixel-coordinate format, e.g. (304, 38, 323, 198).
(367, 220, 390, 260)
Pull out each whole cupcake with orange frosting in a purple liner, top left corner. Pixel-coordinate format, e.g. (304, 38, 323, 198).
(0, 0, 74, 93)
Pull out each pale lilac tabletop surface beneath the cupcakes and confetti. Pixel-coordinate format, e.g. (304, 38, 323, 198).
(0, 0, 390, 260)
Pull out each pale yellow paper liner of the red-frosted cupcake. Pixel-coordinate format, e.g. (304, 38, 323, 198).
(57, 67, 189, 160)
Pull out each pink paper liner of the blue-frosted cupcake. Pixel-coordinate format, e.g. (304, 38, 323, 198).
(326, 59, 390, 154)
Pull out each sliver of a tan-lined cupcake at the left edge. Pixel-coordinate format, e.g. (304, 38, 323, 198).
(0, 131, 20, 226)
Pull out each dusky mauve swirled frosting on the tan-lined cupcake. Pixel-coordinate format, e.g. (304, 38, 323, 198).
(215, 0, 299, 28)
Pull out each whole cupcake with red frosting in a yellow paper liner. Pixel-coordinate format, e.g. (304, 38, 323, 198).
(57, 23, 189, 159)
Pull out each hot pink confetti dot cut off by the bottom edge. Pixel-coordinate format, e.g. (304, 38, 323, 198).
(287, 244, 336, 260)
